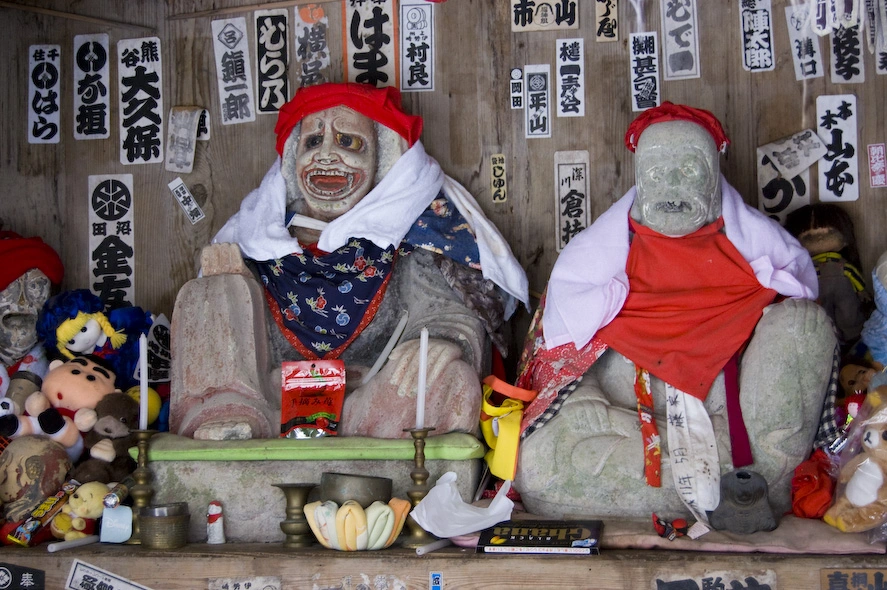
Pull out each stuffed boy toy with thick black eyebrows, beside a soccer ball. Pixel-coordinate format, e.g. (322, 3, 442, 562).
(0, 356, 117, 462)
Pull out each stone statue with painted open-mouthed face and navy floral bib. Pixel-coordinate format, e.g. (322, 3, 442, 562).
(170, 84, 527, 439)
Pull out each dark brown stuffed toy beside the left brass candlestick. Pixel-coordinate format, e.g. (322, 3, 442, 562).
(71, 391, 139, 484)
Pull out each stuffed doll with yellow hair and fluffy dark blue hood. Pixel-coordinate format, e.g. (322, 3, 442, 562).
(37, 289, 152, 389)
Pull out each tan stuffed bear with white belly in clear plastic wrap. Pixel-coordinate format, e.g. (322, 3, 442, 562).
(823, 400, 887, 533)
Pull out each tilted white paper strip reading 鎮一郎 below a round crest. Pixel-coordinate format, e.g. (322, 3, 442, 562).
(212, 17, 256, 125)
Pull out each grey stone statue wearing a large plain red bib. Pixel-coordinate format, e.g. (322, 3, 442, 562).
(515, 103, 836, 521)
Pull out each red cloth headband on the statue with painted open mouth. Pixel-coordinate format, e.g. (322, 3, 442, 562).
(274, 82, 422, 156)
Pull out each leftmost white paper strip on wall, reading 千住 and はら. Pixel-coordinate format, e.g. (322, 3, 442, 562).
(27, 45, 62, 143)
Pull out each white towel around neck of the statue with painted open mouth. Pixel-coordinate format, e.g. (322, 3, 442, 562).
(213, 141, 529, 305)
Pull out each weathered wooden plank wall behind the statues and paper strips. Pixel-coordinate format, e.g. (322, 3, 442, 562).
(0, 0, 887, 370)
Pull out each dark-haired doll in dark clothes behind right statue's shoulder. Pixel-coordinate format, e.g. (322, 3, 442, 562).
(785, 203, 871, 350)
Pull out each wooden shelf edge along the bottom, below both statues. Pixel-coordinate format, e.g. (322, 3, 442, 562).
(0, 543, 887, 590)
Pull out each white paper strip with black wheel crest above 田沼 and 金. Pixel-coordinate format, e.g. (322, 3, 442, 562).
(87, 174, 135, 307)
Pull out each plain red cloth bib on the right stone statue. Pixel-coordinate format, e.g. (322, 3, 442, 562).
(597, 219, 776, 400)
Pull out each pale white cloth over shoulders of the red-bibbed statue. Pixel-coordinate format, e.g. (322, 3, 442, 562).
(542, 175, 819, 349)
